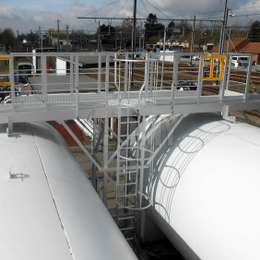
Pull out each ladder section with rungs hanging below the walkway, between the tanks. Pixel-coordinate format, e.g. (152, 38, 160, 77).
(116, 106, 141, 242)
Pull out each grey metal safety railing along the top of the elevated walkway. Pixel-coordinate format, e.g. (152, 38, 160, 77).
(0, 52, 260, 114)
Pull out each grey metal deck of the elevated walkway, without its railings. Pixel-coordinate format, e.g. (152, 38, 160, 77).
(0, 90, 260, 123)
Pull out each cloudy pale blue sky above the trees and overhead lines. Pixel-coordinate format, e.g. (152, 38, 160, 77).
(0, 0, 260, 31)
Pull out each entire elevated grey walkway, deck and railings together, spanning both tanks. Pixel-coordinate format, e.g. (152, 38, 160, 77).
(0, 50, 260, 123)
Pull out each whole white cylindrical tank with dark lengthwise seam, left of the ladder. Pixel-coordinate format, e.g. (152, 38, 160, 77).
(0, 124, 137, 260)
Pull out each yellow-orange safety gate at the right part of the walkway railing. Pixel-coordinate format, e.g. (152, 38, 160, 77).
(202, 55, 227, 81)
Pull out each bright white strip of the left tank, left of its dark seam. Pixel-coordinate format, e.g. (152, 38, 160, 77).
(0, 124, 72, 260)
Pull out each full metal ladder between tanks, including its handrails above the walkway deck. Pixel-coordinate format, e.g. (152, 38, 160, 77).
(116, 54, 156, 243)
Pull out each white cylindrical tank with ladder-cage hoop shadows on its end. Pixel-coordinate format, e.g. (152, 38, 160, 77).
(153, 115, 260, 260)
